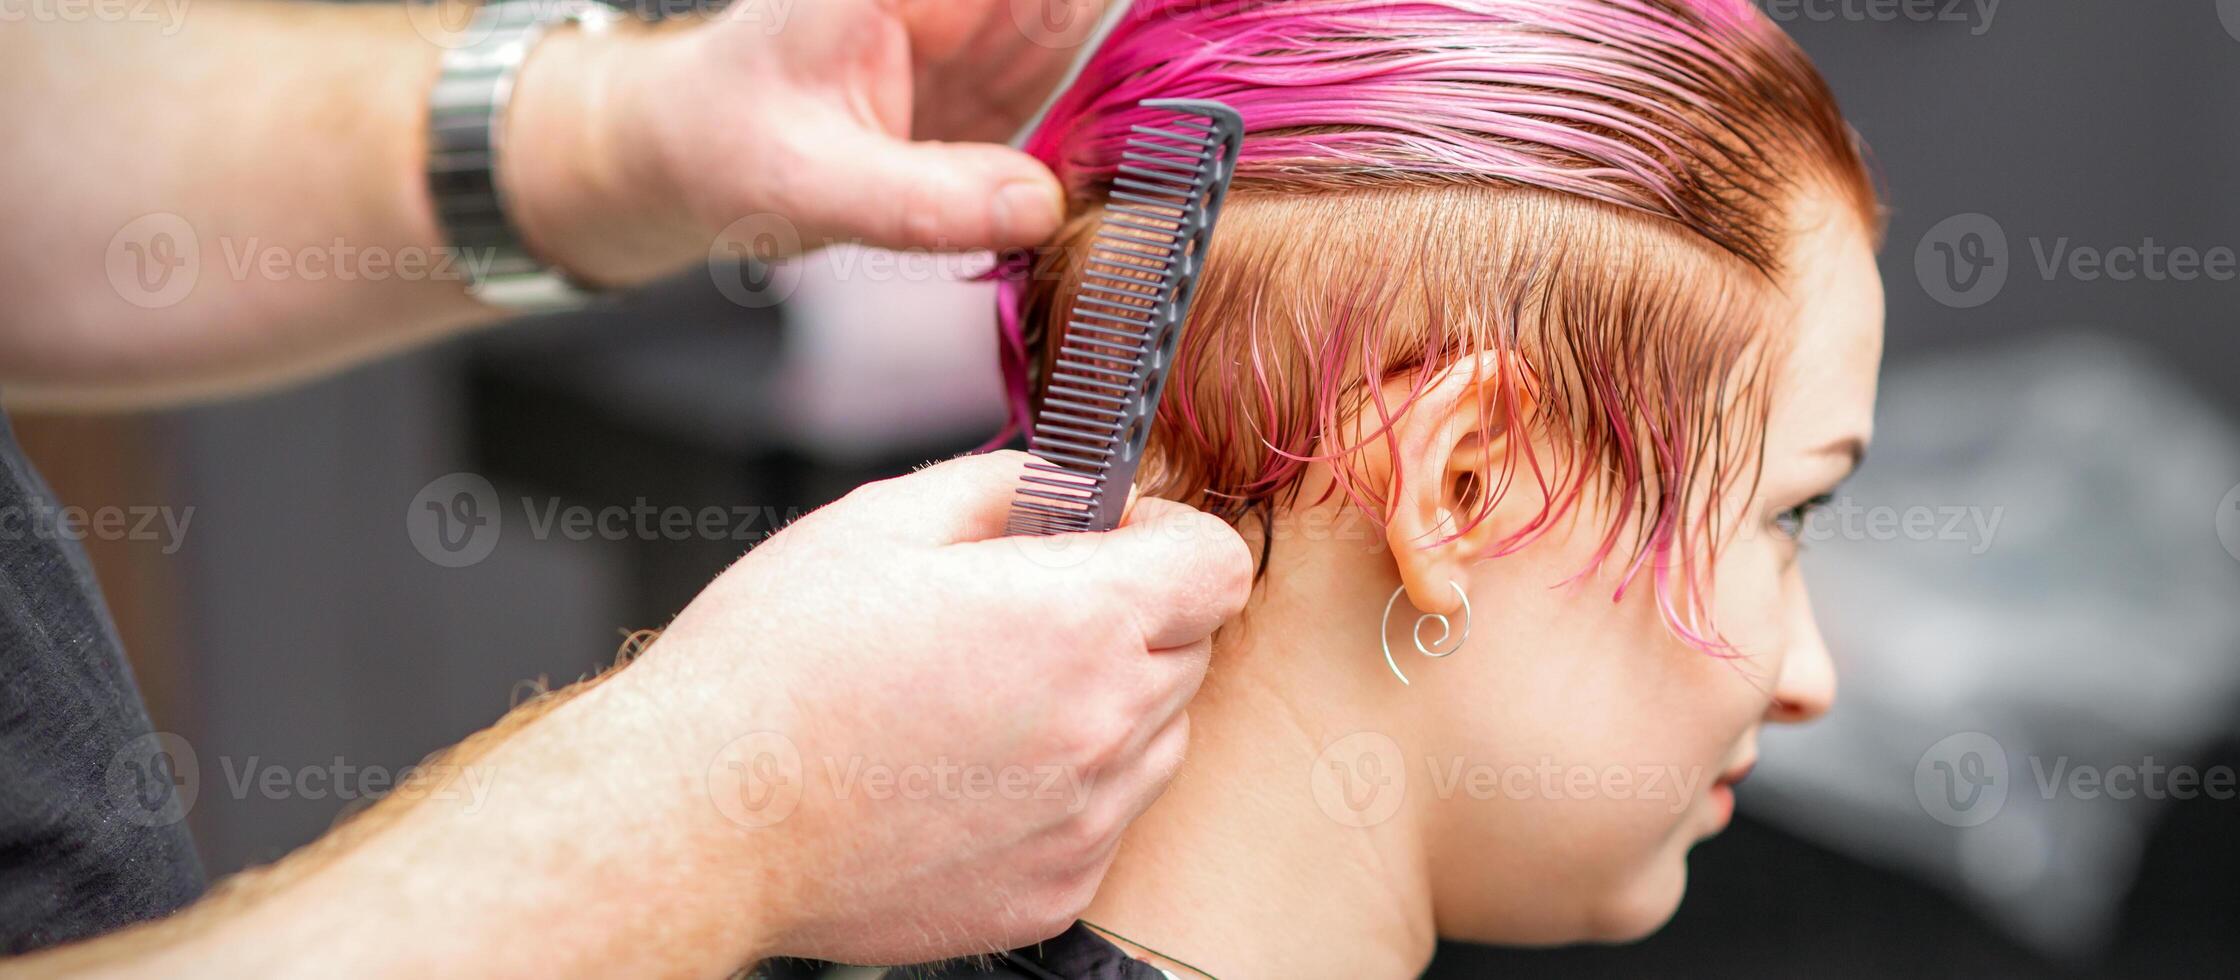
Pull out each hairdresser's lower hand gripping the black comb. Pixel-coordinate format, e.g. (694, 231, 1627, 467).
(609, 452, 1252, 962)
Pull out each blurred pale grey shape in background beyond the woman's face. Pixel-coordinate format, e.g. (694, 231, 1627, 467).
(1745, 333, 2240, 953)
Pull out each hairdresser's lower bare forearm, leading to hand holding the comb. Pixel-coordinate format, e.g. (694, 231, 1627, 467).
(0, 671, 766, 978)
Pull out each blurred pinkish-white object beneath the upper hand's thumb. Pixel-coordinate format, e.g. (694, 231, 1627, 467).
(780, 246, 1004, 459)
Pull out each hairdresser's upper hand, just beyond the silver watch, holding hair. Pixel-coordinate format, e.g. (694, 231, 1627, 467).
(506, 0, 1109, 282)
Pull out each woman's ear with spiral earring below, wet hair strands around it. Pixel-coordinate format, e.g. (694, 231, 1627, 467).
(1384, 351, 1534, 613)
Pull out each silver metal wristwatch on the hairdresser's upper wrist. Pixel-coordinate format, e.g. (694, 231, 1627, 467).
(428, 0, 625, 311)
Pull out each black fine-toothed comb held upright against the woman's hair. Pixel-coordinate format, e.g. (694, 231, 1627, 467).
(1006, 98, 1245, 535)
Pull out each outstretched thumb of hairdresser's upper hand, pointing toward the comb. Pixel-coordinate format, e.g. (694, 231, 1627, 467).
(797, 132, 1064, 251)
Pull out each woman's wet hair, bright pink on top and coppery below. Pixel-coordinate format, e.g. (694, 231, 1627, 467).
(997, 0, 1879, 649)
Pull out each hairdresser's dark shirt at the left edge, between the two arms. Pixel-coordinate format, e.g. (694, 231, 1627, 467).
(0, 412, 202, 955)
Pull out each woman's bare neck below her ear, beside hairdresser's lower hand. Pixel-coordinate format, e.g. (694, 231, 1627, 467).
(1082, 609, 1436, 980)
